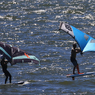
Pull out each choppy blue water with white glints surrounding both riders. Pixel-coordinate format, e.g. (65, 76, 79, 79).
(0, 0, 95, 95)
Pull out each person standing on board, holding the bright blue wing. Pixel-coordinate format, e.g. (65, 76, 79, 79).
(70, 44, 82, 74)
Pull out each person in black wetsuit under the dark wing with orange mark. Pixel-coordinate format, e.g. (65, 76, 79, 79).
(1, 58, 11, 84)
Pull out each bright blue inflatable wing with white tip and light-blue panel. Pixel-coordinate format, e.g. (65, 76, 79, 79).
(59, 22, 95, 52)
